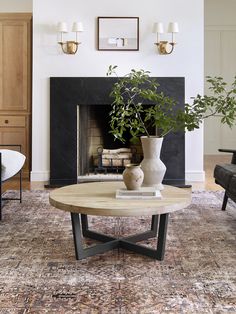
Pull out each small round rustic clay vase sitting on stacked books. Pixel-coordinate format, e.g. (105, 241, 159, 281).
(123, 164, 144, 190)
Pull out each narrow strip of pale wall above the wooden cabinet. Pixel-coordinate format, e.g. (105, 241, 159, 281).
(0, 0, 33, 13)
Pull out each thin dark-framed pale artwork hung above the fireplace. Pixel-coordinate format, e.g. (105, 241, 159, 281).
(98, 17, 139, 51)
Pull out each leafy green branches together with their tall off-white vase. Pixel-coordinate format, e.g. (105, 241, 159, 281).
(107, 66, 236, 189)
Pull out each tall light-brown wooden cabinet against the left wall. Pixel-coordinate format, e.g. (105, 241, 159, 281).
(0, 13, 32, 176)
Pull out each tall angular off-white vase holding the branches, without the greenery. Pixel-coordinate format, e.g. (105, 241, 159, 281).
(141, 136, 166, 190)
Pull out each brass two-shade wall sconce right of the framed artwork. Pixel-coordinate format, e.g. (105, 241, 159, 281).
(153, 22, 179, 55)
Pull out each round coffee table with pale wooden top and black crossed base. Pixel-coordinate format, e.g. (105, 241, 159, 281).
(49, 182, 191, 260)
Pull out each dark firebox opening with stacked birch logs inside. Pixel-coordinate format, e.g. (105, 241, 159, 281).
(77, 105, 142, 175)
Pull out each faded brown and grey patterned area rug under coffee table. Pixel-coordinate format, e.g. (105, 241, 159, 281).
(0, 191, 236, 314)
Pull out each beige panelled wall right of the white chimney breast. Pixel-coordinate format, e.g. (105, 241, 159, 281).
(204, 0, 236, 155)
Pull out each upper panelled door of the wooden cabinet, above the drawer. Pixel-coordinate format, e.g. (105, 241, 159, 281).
(0, 15, 31, 112)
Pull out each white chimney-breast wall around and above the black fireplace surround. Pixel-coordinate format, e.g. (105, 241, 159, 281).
(31, 0, 204, 181)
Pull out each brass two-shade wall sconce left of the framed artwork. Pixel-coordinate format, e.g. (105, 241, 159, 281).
(57, 22, 84, 55)
